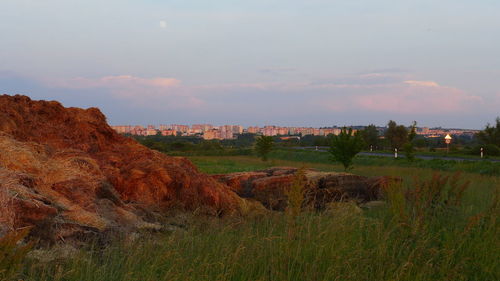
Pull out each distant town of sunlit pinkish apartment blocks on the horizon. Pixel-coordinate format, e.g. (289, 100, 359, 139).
(111, 124, 479, 140)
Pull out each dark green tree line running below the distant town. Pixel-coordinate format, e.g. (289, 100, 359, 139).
(133, 118, 500, 164)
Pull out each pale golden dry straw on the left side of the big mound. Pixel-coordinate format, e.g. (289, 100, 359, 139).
(0, 133, 106, 228)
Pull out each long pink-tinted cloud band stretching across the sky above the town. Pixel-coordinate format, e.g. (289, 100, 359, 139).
(45, 73, 490, 114)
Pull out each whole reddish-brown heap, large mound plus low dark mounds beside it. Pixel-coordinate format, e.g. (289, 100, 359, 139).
(0, 95, 398, 241)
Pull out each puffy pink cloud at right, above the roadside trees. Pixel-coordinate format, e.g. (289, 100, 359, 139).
(308, 73, 483, 115)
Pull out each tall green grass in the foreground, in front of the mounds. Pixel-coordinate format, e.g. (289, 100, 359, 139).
(15, 184, 500, 281)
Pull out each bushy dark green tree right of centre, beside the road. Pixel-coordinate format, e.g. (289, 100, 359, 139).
(328, 127, 364, 171)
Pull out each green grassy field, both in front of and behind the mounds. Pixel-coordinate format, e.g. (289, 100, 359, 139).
(4, 151, 500, 281)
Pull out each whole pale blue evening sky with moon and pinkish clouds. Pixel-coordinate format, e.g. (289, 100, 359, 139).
(0, 0, 500, 129)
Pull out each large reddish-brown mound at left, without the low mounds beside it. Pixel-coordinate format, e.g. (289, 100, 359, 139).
(0, 95, 249, 239)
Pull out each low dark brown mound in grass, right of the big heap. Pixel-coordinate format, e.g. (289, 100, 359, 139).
(213, 167, 400, 210)
